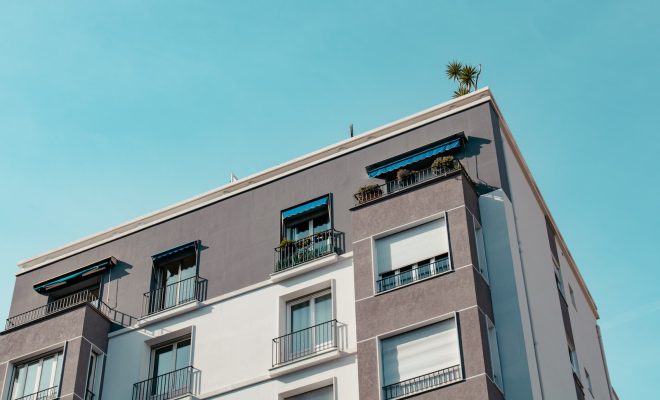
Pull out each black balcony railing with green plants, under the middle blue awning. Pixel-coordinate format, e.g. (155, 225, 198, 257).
(275, 229, 344, 272)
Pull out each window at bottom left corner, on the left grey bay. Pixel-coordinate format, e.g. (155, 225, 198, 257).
(11, 352, 63, 400)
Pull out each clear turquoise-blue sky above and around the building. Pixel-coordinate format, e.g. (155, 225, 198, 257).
(0, 0, 660, 399)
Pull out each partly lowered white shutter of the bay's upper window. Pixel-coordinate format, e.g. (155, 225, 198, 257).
(376, 218, 449, 274)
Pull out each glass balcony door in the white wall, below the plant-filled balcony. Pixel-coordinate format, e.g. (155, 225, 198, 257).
(286, 290, 334, 359)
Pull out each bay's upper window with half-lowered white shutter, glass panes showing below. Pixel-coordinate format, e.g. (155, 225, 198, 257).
(375, 218, 450, 292)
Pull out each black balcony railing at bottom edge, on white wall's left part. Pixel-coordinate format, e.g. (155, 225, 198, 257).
(133, 367, 199, 400)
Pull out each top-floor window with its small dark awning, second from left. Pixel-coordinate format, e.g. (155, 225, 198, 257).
(150, 242, 198, 314)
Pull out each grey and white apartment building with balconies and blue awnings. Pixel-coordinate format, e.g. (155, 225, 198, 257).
(0, 88, 616, 400)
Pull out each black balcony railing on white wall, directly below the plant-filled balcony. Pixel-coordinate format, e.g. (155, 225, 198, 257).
(273, 319, 337, 366)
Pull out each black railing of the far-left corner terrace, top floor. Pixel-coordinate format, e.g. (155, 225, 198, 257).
(5, 290, 135, 330)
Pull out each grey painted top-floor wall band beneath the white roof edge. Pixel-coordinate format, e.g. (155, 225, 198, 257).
(10, 104, 500, 324)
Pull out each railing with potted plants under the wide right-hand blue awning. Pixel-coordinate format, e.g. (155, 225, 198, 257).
(354, 160, 463, 206)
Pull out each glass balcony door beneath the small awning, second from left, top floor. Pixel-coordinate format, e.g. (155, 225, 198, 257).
(151, 252, 197, 312)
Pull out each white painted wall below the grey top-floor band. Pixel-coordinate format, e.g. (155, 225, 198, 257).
(103, 260, 357, 400)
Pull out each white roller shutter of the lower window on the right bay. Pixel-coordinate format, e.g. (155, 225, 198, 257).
(381, 318, 460, 386)
